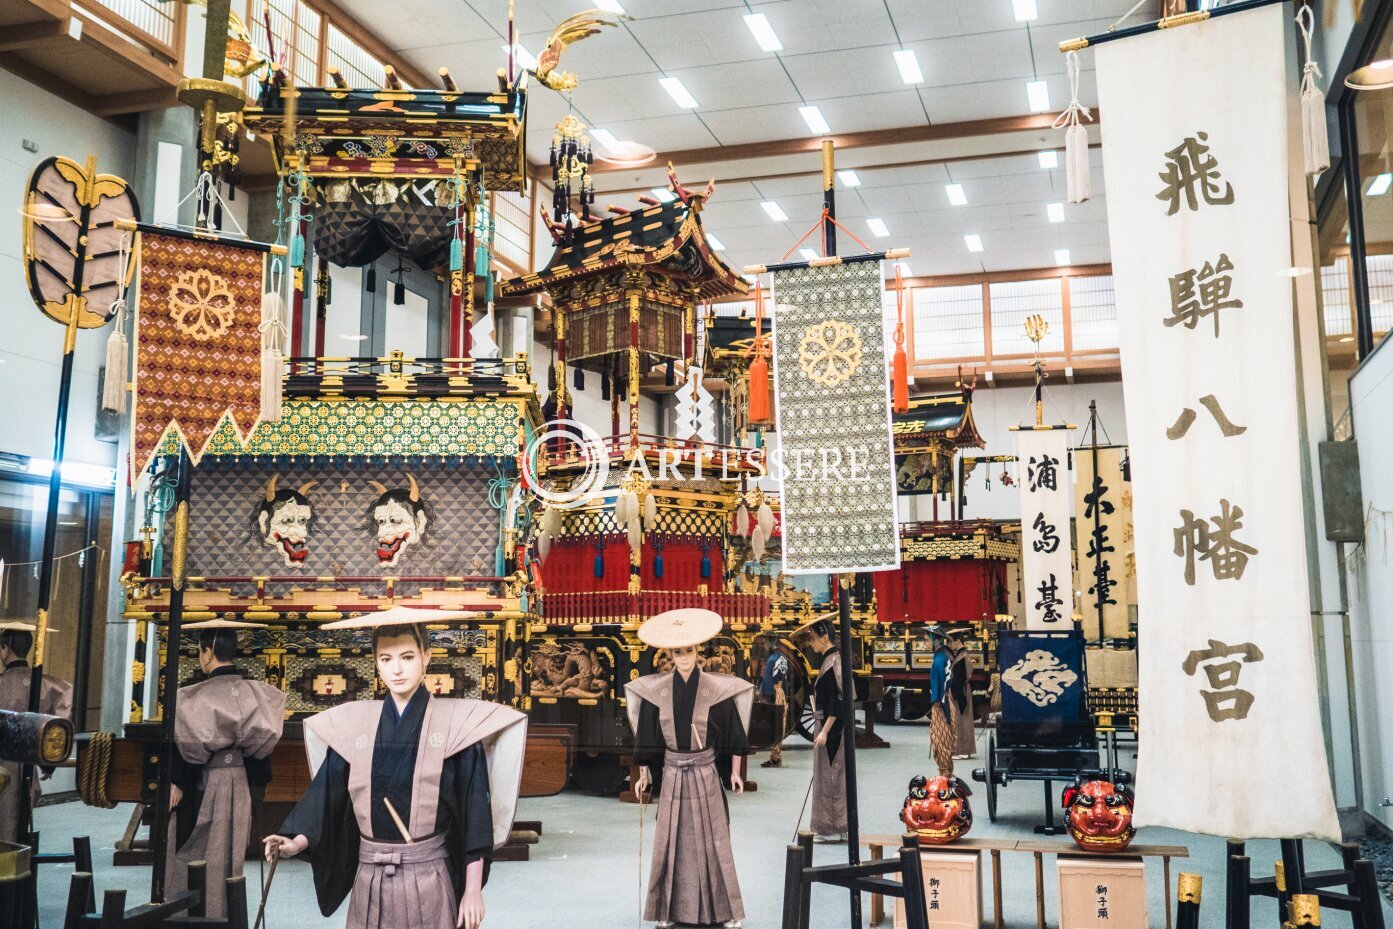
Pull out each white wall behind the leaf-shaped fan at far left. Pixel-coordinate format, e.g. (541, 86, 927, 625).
(0, 70, 135, 467)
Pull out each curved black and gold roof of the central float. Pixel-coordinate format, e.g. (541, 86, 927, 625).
(501, 187, 749, 301)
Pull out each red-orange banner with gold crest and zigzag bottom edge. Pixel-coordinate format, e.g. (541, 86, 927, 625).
(131, 227, 267, 483)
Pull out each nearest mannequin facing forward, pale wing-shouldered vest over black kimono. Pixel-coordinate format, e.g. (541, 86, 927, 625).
(266, 607, 527, 929)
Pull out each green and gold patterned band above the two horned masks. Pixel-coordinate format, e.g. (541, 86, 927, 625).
(159, 400, 524, 458)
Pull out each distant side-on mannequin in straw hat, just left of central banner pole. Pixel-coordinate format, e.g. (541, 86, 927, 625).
(794, 617, 847, 843)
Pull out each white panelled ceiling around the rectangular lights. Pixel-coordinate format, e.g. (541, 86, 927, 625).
(325, 0, 1153, 276)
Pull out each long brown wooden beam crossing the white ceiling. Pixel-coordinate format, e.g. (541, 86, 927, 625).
(591, 110, 1080, 174)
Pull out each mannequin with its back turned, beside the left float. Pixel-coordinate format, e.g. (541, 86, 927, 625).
(166, 620, 286, 916)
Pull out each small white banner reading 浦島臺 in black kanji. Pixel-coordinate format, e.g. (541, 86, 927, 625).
(1015, 426, 1074, 630)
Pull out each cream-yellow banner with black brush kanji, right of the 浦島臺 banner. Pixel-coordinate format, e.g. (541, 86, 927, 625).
(1074, 446, 1131, 642)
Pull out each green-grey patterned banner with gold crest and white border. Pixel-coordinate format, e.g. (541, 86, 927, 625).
(770, 260, 900, 574)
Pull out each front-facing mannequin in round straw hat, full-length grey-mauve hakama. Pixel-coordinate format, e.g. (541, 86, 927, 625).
(624, 610, 755, 929)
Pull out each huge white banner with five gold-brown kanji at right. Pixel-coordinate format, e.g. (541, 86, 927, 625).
(1095, 4, 1340, 840)
